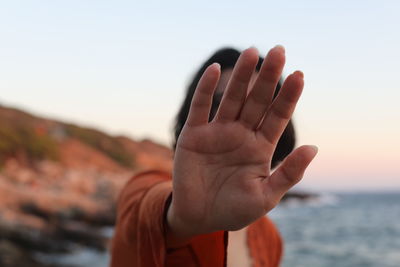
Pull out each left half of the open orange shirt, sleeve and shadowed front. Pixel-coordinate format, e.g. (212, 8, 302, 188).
(111, 171, 227, 267)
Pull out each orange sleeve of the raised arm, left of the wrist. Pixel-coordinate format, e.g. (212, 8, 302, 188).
(111, 171, 172, 267)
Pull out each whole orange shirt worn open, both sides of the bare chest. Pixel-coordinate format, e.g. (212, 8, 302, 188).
(111, 171, 282, 267)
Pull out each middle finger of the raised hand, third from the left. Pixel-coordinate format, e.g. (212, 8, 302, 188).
(240, 45, 285, 129)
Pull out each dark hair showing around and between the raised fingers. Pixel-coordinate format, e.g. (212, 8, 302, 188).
(173, 48, 296, 168)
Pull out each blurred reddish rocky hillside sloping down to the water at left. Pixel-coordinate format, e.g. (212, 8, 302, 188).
(0, 106, 172, 266)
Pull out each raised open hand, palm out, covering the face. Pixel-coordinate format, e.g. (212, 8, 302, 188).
(167, 46, 317, 241)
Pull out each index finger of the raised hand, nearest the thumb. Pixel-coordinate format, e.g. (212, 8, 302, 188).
(259, 71, 304, 146)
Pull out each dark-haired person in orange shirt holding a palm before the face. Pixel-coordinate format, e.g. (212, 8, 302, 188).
(111, 46, 317, 267)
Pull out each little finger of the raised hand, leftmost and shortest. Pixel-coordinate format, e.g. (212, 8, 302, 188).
(186, 63, 221, 126)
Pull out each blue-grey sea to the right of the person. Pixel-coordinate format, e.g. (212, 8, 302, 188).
(269, 193, 400, 267)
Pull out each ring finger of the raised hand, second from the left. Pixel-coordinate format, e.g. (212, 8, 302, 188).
(215, 47, 258, 121)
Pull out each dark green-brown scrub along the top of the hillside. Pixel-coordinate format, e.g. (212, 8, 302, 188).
(0, 105, 134, 167)
